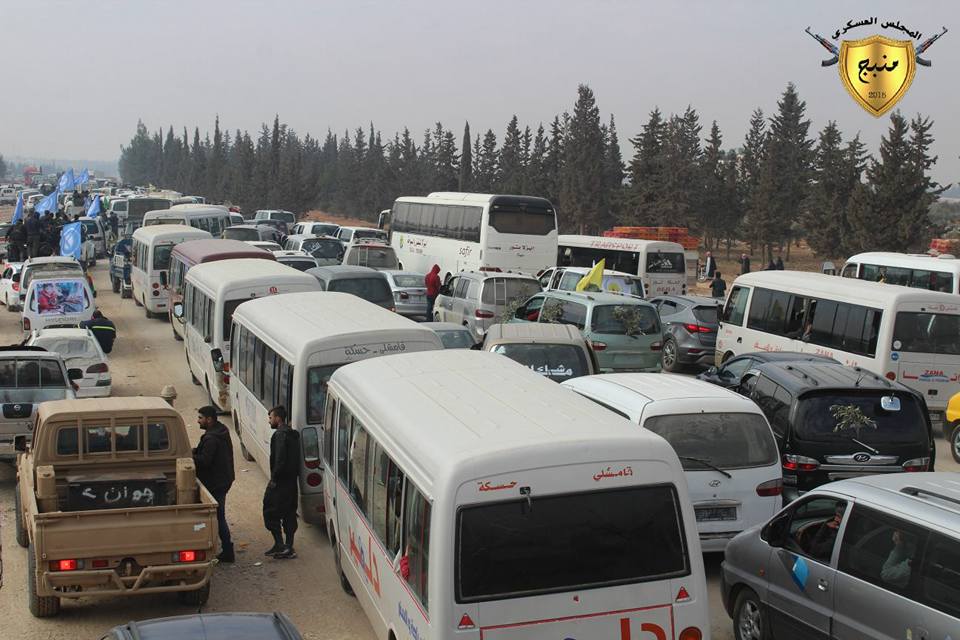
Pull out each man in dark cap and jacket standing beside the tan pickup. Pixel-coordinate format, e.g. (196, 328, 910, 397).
(193, 406, 235, 562)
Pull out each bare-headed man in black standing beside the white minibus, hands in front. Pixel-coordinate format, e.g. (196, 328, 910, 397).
(263, 406, 300, 559)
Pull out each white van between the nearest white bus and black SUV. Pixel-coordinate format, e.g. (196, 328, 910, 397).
(563, 373, 783, 552)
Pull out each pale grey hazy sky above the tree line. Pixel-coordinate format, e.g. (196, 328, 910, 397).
(0, 0, 960, 183)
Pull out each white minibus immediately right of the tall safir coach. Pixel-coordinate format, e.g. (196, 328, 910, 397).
(557, 235, 687, 296)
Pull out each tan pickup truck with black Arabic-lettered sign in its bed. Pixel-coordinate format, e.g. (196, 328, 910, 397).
(15, 397, 217, 618)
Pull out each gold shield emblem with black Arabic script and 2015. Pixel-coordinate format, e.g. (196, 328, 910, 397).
(838, 35, 917, 117)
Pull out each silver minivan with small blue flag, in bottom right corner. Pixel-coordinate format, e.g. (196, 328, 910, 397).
(721, 472, 960, 640)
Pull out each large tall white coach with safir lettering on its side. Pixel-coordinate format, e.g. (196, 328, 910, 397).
(390, 192, 557, 281)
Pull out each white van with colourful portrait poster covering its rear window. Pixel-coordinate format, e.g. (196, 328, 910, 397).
(20, 273, 94, 331)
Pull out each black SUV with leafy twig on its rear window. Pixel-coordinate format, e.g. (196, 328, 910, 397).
(738, 362, 936, 500)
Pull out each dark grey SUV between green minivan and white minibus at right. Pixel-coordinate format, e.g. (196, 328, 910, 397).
(650, 296, 723, 372)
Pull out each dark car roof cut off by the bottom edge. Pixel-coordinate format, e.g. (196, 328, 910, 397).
(101, 612, 303, 640)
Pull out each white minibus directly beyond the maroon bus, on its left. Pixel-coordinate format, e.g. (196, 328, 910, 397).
(130, 224, 212, 318)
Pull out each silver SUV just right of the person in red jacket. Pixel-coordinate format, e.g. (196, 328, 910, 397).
(433, 271, 540, 342)
